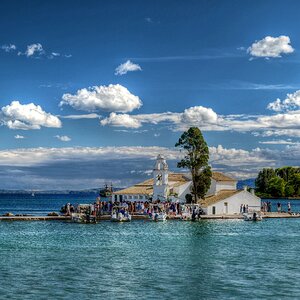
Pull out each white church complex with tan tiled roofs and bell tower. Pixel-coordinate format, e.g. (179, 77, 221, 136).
(113, 155, 261, 215)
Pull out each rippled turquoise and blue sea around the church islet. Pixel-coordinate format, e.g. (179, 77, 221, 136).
(0, 195, 300, 299)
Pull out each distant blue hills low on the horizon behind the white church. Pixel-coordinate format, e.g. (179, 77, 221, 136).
(0, 178, 255, 195)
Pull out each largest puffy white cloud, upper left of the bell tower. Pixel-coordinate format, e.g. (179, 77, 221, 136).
(60, 84, 142, 113)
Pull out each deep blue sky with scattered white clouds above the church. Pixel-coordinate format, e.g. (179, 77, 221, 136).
(0, 0, 300, 190)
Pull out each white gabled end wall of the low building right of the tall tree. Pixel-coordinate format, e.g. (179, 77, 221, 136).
(207, 191, 261, 215)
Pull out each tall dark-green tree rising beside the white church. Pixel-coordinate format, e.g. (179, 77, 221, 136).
(175, 127, 212, 202)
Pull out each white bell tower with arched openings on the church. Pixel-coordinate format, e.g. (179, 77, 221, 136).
(153, 154, 169, 201)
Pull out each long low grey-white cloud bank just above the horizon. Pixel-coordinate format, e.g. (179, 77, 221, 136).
(0, 144, 300, 189)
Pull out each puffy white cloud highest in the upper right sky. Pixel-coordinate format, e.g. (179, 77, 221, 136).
(247, 35, 294, 58)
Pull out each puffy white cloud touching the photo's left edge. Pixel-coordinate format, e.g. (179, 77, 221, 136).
(0, 101, 61, 130)
